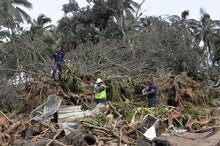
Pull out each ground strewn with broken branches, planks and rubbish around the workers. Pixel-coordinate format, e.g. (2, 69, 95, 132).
(0, 67, 220, 146)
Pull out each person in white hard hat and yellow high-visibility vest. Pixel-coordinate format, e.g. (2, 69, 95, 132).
(94, 78, 107, 104)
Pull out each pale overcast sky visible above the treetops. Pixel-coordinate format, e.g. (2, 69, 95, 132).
(27, 0, 220, 24)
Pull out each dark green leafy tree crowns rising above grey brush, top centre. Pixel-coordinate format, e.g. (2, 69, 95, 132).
(58, 0, 139, 48)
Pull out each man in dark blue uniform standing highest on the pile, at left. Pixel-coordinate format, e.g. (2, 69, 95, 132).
(52, 46, 65, 80)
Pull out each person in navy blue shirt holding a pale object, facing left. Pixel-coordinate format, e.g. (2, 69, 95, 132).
(143, 78, 157, 107)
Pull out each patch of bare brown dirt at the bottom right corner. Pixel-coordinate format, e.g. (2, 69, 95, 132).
(162, 131, 220, 146)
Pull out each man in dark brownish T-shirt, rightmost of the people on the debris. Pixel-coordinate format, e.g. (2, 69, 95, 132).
(167, 76, 179, 107)
